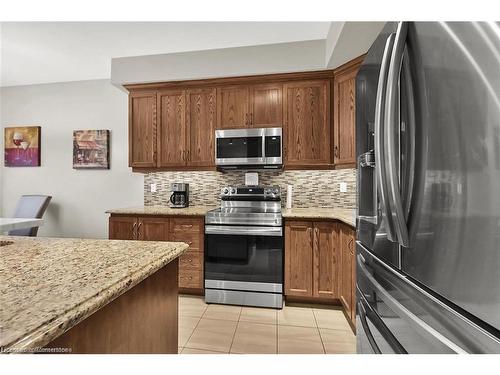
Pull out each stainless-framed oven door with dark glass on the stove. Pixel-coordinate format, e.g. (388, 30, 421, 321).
(205, 225, 283, 293)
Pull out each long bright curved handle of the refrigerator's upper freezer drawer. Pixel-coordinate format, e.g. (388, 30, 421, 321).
(356, 254, 467, 354)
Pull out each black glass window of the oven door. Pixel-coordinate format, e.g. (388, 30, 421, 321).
(205, 234, 283, 283)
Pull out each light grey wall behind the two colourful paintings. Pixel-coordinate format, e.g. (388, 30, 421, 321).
(0, 80, 143, 238)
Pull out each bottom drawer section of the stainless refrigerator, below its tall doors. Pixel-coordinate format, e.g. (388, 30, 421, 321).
(356, 243, 500, 354)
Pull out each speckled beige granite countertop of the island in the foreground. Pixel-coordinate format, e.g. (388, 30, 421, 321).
(0, 236, 188, 350)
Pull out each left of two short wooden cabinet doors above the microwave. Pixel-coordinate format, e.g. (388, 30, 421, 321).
(217, 86, 250, 129)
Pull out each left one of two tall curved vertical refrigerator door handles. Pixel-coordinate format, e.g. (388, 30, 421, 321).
(374, 33, 396, 242)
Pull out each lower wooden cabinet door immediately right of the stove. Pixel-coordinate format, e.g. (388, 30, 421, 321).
(285, 221, 313, 297)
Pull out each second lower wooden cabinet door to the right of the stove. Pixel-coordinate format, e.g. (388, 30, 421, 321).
(313, 222, 340, 298)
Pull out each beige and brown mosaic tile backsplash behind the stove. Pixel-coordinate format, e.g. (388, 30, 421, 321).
(144, 169, 356, 208)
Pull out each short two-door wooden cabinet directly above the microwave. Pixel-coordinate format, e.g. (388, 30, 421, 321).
(217, 83, 283, 129)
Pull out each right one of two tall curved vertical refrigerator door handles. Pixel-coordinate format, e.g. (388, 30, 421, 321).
(384, 22, 410, 247)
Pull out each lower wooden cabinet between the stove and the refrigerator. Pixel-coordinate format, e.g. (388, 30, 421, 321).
(285, 220, 356, 325)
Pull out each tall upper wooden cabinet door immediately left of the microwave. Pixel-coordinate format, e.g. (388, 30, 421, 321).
(186, 89, 216, 167)
